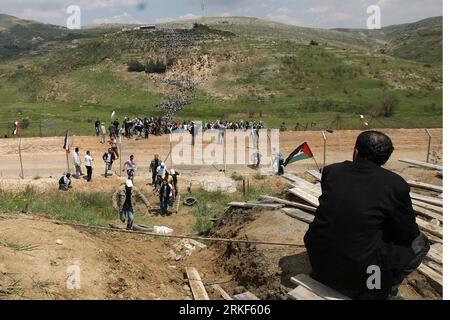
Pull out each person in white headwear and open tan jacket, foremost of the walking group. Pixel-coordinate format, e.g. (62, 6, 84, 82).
(112, 180, 150, 230)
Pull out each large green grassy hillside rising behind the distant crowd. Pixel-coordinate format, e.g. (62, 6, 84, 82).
(0, 18, 442, 135)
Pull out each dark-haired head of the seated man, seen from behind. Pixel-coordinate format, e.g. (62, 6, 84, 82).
(354, 131, 394, 166)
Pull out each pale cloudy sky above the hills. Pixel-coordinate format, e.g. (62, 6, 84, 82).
(0, 0, 443, 28)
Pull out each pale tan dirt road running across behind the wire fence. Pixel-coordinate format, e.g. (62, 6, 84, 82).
(0, 129, 442, 179)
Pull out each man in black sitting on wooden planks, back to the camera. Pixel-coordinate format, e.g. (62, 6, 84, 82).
(304, 131, 430, 299)
